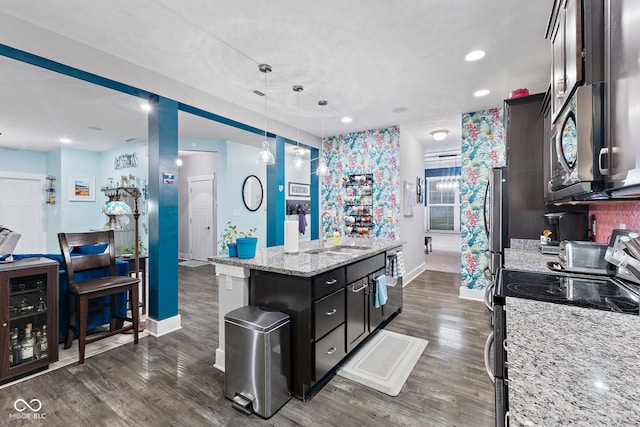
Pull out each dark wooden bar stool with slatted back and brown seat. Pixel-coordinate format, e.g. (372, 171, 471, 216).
(58, 230, 140, 363)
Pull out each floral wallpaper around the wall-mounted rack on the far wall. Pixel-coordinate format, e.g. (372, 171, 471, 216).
(320, 126, 400, 239)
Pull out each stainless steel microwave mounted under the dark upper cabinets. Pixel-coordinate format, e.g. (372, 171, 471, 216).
(545, 83, 607, 201)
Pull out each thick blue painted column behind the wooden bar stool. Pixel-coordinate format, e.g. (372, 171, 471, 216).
(149, 96, 178, 321)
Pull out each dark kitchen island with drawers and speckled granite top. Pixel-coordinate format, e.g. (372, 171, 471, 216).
(212, 239, 403, 400)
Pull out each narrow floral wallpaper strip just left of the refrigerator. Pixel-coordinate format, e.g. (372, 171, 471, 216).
(460, 108, 506, 290)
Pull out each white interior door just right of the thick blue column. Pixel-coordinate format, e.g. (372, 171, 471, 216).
(188, 175, 217, 261)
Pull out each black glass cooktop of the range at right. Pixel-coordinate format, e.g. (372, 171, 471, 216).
(496, 269, 640, 315)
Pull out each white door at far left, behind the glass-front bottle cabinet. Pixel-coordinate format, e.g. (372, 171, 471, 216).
(0, 176, 45, 254)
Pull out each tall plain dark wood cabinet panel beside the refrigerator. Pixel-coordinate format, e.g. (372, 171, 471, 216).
(504, 94, 546, 239)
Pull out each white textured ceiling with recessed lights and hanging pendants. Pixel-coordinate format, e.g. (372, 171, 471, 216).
(0, 0, 553, 155)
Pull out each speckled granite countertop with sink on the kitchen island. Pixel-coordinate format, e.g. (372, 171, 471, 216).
(210, 238, 405, 277)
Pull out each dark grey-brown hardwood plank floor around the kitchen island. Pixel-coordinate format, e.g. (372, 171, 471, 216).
(0, 266, 494, 427)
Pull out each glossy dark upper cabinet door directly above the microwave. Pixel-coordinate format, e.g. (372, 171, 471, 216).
(547, 0, 583, 120)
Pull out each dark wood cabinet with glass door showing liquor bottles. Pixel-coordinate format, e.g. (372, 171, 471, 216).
(0, 258, 58, 382)
